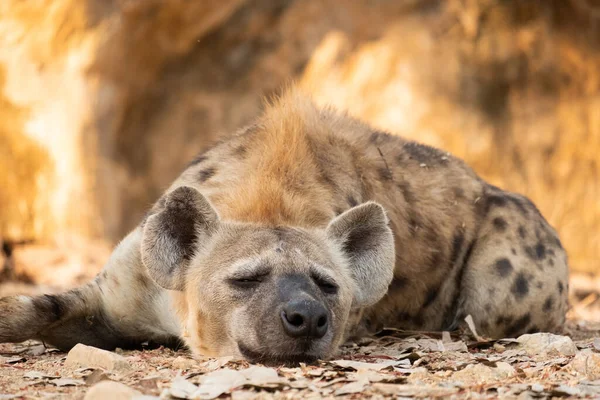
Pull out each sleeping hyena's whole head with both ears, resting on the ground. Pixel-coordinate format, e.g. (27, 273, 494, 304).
(142, 186, 395, 363)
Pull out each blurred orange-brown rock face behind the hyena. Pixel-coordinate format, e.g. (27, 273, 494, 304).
(0, 0, 600, 270)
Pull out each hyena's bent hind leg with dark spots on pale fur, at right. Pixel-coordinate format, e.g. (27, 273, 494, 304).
(458, 195, 568, 338)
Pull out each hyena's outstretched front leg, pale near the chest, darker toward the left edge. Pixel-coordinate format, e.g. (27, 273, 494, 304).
(0, 229, 180, 350)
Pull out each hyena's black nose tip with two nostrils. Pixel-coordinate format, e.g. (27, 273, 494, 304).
(281, 299, 329, 339)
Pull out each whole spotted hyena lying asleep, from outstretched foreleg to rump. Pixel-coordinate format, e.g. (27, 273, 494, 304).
(0, 93, 568, 361)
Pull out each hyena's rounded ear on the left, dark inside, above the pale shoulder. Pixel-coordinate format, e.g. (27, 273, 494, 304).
(141, 186, 219, 290)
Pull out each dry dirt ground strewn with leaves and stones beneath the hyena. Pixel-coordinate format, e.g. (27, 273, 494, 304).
(0, 308, 600, 400)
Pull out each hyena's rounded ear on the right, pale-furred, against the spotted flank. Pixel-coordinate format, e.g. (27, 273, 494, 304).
(327, 202, 396, 308)
